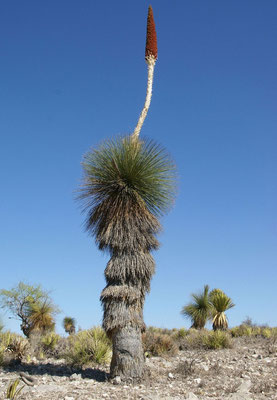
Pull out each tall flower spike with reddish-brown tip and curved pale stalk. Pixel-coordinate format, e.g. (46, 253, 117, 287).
(132, 6, 158, 139)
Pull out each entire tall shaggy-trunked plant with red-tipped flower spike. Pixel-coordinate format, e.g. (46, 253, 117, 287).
(77, 7, 175, 379)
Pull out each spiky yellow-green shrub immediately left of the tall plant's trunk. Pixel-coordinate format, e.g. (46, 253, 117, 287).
(64, 327, 112, 366)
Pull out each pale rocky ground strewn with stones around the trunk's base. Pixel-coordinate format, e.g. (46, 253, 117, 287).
(0, 337, 277, 400)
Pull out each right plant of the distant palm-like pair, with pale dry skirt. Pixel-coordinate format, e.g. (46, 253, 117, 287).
(209, 289, 235, 331)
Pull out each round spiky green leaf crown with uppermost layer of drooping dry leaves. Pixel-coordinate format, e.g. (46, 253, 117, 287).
(79, 136, 175, 252)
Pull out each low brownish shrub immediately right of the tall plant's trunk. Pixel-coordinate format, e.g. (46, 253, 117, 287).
(142, 330, 178, 357)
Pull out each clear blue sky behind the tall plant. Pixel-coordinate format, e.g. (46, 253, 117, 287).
(0, 0, 277, 332)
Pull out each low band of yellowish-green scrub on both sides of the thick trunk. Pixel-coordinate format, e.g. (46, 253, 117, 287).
(0, 324, 277, 367)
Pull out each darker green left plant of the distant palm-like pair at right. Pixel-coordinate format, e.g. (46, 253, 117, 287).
(181, 285, 211, 329)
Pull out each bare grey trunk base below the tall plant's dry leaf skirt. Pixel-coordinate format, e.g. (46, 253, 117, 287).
(110, 324, 144, 380)
